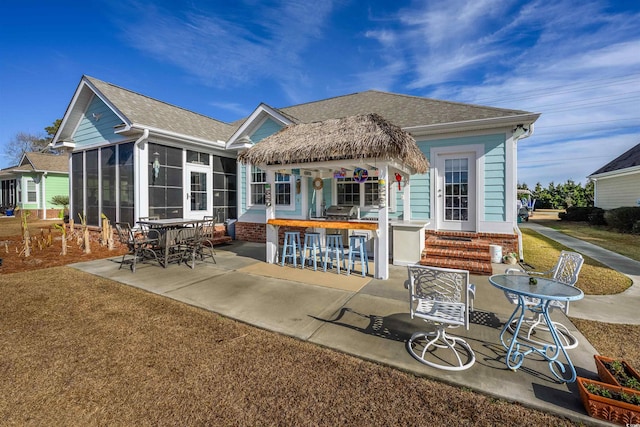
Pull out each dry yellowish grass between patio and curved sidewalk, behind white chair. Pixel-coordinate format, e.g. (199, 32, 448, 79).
(522, 228, 632, 295)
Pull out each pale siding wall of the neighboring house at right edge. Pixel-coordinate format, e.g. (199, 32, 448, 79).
(594, 172, 640, 210)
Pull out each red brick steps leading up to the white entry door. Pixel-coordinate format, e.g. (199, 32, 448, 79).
(420, 231, 493, 276)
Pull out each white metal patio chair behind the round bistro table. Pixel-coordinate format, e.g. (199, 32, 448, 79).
(505, 251, 584, 349)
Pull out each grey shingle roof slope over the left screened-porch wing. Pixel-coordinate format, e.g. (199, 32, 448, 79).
(84, 76, 236, 141)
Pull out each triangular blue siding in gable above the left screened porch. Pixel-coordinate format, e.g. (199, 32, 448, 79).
(73, 96, 125, 147)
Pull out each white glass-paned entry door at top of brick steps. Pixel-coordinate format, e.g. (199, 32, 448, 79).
(436, 153, 476, 231)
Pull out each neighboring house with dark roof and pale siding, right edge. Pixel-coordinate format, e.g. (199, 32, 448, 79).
(587, 144, 640, 209)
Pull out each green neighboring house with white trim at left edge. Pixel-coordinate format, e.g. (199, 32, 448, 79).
(0, 152, 69, 219)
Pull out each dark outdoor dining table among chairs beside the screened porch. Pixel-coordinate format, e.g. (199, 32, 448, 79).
(138, 218, 202, 268)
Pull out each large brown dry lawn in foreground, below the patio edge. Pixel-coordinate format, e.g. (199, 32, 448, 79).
(0, 267, 572, 426)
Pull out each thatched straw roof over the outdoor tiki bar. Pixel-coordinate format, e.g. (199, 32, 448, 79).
(238, 114, 429, 173)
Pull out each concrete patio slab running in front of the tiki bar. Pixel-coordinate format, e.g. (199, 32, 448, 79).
(72, 241, 598, 424)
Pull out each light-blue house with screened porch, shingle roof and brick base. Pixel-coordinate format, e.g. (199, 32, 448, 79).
(53, 76, 539, 278)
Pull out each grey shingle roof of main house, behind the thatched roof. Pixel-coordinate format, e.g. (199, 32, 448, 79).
(278, 90, 531, 128)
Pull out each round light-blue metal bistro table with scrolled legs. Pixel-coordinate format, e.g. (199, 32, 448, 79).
(489, 274, 584, 382)
